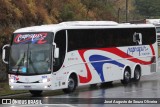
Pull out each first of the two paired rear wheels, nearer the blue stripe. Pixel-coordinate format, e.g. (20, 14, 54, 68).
(121, 69, 131, 85)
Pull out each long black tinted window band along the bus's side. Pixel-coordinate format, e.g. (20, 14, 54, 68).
(68, 28, 156, 51)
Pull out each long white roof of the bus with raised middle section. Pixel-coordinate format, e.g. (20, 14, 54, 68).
(14, 21, 154, 33)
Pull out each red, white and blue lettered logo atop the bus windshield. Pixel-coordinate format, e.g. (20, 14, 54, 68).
(14, 33, 47, 44)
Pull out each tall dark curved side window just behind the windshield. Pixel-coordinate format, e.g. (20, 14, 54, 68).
(53, 30, 66, 71)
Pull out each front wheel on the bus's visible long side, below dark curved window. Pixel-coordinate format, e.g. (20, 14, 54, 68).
(63, 75, 77, 94)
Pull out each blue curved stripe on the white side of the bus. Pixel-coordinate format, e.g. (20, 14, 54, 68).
(89, 55, 124, 82)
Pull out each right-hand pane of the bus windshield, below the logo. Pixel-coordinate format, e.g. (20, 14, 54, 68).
(28, 45, 51, 74)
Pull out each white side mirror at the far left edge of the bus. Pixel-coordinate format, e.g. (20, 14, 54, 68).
(2, 44, 10, 64)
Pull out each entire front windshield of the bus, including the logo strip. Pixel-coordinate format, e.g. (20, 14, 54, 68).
(9, 33, 53, 75)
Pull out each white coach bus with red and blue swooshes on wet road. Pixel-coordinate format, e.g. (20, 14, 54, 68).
(2, 21, 158, 95)
